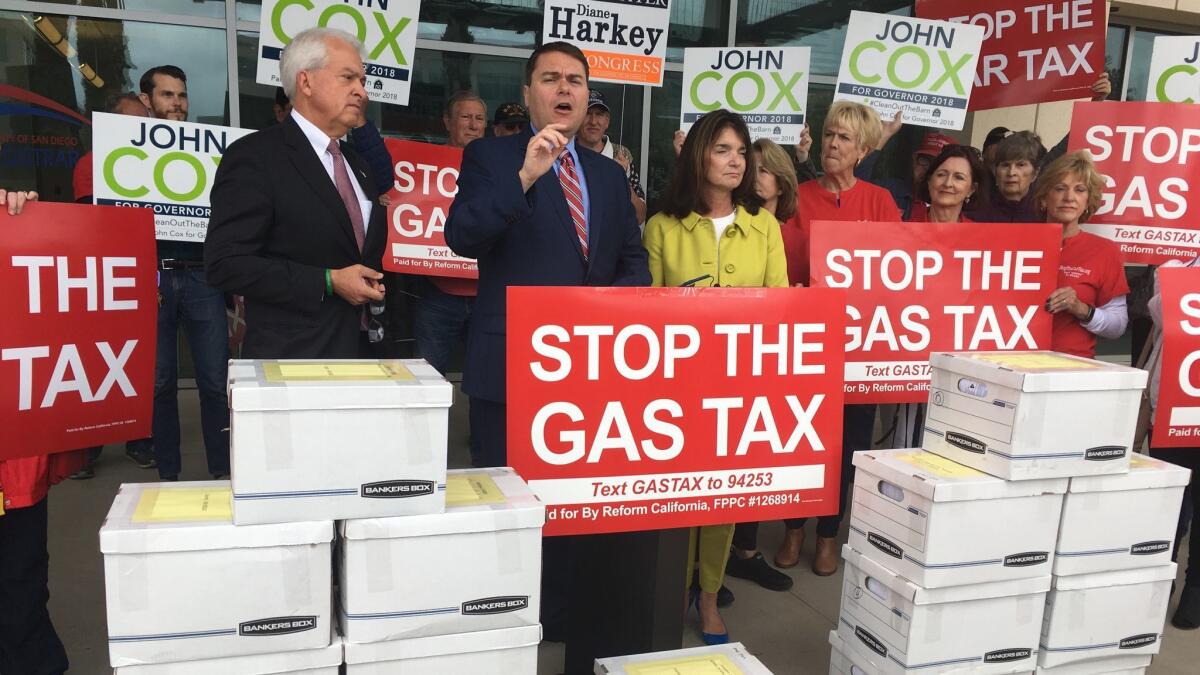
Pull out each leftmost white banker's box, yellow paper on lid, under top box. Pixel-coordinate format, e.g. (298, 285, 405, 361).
(100, 480, 334, 668)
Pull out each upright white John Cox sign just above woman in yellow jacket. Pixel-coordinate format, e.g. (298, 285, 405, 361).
(680, 47, 809, 145)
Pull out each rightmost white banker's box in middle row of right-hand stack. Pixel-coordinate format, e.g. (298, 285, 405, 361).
(1054, 454, 1192, 574)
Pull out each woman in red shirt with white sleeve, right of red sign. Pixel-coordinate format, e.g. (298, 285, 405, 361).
(1034, 151, 1129, 358)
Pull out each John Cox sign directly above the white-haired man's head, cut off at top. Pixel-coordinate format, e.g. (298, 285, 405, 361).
(256, 0, 421, 106)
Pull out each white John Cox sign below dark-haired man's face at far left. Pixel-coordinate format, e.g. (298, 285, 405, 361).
(91, 113, 251, 243)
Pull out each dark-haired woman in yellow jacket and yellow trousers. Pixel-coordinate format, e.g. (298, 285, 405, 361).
(642, 109, 787, 645)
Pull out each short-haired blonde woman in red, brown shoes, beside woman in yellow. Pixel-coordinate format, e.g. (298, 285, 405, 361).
(775, 101, 900, 577)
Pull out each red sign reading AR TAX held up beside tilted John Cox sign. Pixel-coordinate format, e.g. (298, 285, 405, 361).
(917, 0, 1108, 110)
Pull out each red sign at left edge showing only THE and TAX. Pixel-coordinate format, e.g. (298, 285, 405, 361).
(0, 203, 157, 460)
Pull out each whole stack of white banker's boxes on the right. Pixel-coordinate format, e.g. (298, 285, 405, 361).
(830, 352, 1189, 674)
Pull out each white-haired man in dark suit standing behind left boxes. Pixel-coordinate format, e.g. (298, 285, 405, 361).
(204, 29, 388, 359)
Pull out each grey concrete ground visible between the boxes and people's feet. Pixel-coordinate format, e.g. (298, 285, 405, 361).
(46, 390, 1200, 675)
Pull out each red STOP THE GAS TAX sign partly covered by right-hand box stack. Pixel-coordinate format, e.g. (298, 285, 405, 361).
(810, 221, 1062, 404)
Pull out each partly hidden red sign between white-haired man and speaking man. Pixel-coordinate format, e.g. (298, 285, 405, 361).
(383, 138, 479, 279)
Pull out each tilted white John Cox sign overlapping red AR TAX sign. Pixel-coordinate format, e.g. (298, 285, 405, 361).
(834, 12, 983, 129)
